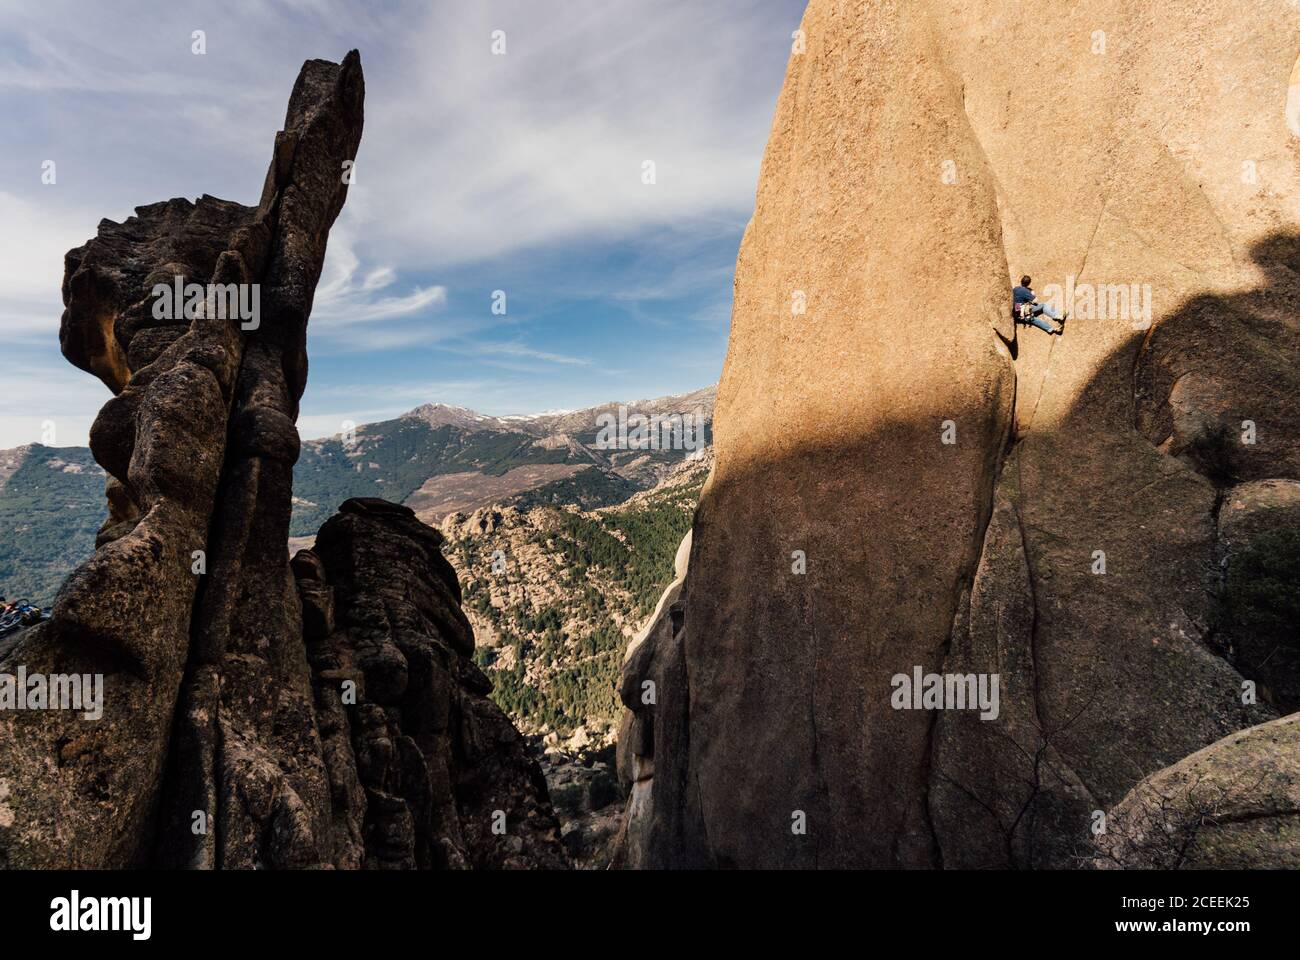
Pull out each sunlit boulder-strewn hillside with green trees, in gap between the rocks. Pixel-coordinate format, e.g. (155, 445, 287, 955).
(442, 457, 711, 749)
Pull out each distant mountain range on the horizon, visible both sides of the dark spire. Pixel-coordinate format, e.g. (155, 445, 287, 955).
(0, 386, 716, 605)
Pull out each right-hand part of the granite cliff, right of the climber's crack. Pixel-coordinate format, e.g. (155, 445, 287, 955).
(931, 3, 1300, 866)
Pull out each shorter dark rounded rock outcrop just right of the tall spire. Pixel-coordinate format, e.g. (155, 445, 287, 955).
(306, 500, 567, 869)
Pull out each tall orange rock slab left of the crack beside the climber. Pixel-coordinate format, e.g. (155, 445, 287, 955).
(629, 3, 1013, 866)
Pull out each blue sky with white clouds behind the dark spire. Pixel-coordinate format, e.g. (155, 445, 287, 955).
(0, 0, 803, 447)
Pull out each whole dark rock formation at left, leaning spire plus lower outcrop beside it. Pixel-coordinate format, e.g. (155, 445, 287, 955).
(0, 51, 563, 868)
